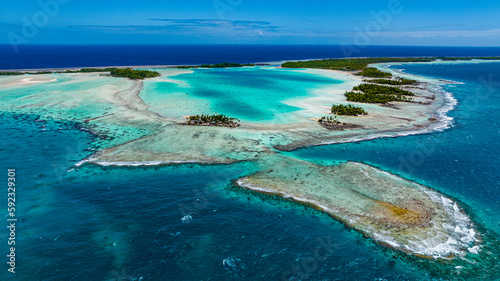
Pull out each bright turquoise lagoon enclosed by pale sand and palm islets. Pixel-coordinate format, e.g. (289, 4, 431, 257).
(141, 67, 345, 124)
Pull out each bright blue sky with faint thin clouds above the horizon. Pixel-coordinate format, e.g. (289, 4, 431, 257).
(0, 0, 500, 46)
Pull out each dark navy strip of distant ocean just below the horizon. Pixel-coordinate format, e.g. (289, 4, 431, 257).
(0, 45, 500, 69)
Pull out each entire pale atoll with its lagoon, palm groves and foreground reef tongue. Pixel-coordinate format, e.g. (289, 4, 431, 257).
(0, 55, 498, 263)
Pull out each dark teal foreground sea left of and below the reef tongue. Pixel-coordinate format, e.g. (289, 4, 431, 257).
(1, 116, 438, 280)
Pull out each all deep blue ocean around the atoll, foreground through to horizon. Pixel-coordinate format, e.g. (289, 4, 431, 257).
(0, 46, 500, 281)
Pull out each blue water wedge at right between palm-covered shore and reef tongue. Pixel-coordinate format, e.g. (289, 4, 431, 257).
(293, 63, 500, 233)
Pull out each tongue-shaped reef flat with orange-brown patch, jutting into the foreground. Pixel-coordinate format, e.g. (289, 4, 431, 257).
(235, 157, 480, 259)
